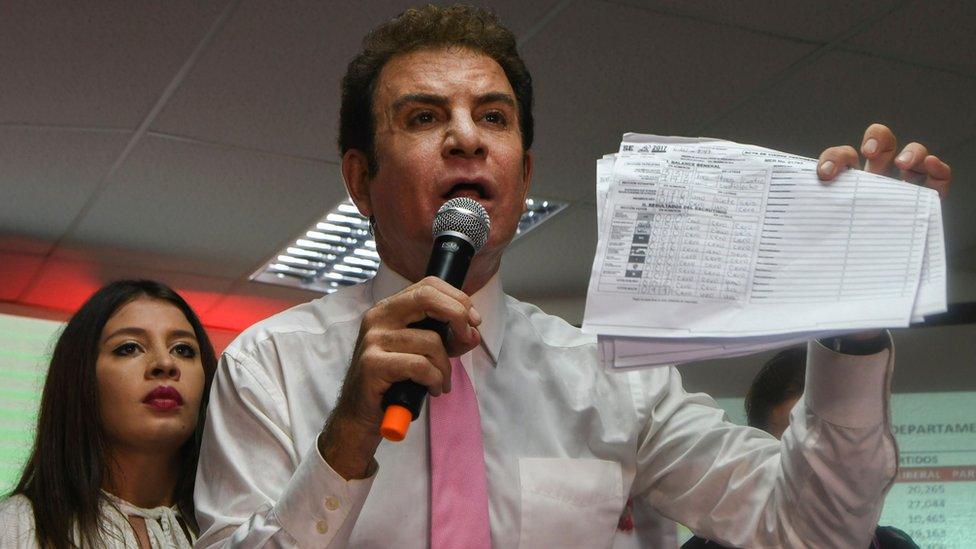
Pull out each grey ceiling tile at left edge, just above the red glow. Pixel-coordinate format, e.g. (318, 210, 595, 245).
(0, 127, 129, 241)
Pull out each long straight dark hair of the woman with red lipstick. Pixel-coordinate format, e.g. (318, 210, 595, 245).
(10, 280, 217, 549)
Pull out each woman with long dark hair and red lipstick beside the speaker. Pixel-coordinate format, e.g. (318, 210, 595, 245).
(0, 280, 216, 549)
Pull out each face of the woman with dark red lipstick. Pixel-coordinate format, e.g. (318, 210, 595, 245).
(95, 297, 205, 452)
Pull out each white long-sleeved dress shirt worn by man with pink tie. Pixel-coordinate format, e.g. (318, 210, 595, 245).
(196, 266, 896, 548)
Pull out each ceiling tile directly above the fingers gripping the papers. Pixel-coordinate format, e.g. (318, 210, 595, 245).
(705, 51, 976, 162)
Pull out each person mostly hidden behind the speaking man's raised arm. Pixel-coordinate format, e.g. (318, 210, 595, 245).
(681, 347, 918, 549)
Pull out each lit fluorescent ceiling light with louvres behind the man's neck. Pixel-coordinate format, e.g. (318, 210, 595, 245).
(250, 198, 568, 293)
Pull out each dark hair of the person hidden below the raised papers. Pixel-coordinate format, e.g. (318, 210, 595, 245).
(745, 347, 807, 430)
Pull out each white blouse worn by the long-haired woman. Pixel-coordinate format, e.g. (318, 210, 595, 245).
(0, 493, 196, 549)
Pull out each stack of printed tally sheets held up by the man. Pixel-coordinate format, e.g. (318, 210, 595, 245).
(583, 133, 946, 368)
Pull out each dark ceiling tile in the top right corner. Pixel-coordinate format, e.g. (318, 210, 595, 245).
(847, 1, 976, 77)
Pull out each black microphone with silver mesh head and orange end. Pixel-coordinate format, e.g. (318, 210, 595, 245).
(380, 197, 491, 442)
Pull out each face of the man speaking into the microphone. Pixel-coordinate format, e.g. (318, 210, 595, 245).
(343, 48, 531, 280)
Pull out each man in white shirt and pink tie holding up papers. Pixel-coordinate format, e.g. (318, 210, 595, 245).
(196, 7, 948, 547)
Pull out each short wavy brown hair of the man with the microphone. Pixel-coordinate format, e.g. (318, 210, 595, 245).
(339, 5, 533, 177)
